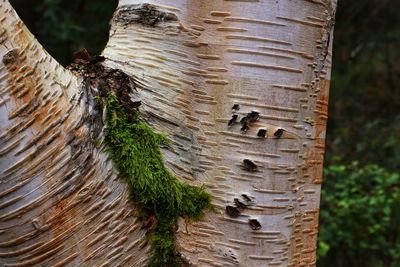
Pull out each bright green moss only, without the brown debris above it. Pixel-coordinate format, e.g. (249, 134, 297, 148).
(105, 94, 211, 267)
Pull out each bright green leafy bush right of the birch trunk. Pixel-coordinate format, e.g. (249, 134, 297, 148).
(318, 163, 400, 267)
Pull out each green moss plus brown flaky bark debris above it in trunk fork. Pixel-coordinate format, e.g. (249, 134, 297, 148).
(68, 54, 212, 267)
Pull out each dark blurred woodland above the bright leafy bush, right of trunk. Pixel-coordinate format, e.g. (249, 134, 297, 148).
(326, 0, 400, 171)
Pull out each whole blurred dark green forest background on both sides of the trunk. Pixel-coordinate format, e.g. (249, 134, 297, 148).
(11, 0, 400, 267)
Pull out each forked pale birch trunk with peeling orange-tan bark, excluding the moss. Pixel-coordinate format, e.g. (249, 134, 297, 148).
(0, 0, 336, 266)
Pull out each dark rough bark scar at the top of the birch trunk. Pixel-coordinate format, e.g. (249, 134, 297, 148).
(113, 4, 178, 26)
